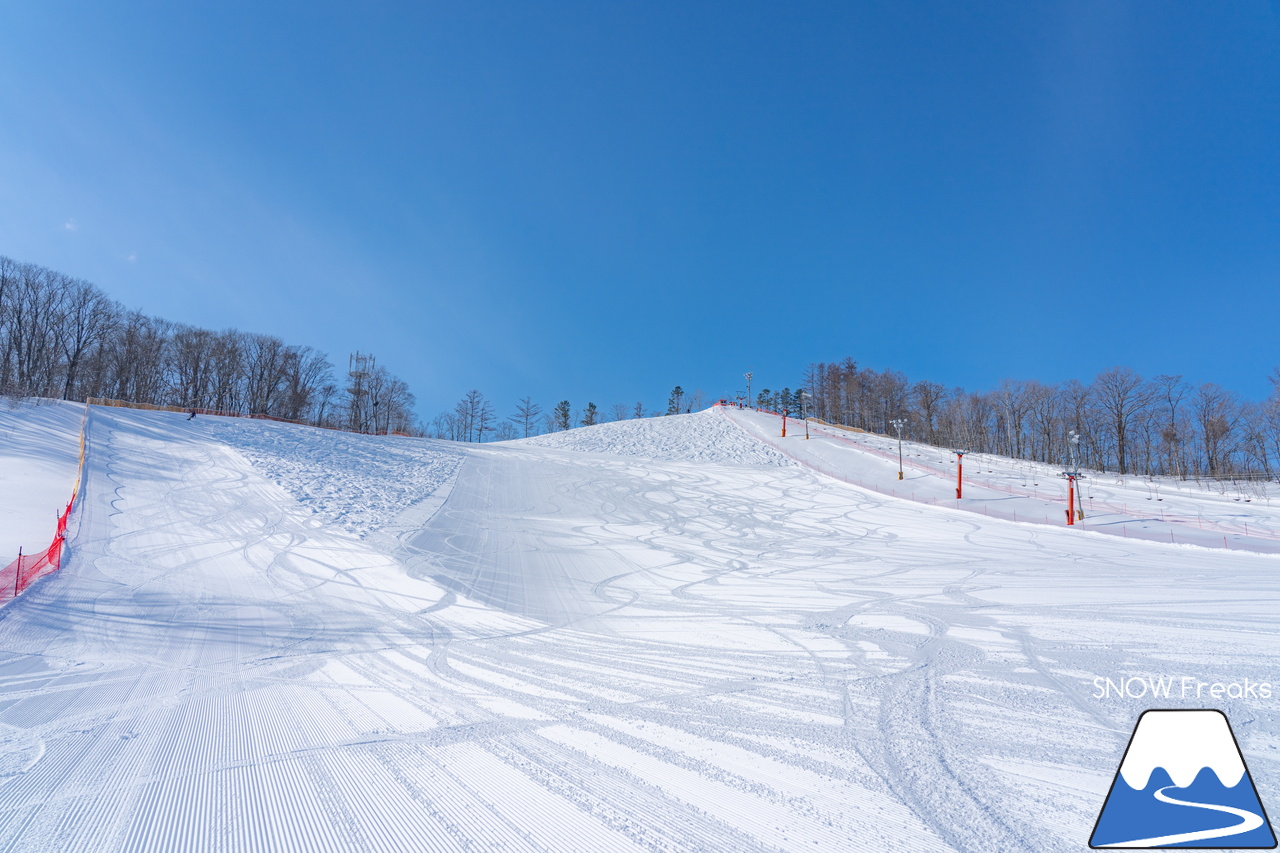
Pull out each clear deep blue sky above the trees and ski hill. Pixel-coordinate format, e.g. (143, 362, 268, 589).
(0, 0, 1280, 419)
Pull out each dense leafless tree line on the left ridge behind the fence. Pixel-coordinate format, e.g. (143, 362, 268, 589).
(0, 256, 420, 434)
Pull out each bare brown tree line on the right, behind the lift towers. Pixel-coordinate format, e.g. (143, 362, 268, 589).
(803, 359, 1280, 479)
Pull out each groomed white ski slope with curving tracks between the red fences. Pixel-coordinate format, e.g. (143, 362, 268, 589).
(0, 409, 1280, 853)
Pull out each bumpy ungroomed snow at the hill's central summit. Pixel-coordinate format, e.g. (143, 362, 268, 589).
(512, 409, 794, 465)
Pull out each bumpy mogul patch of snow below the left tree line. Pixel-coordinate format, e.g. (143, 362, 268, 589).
(207, 418, 462, 537)
